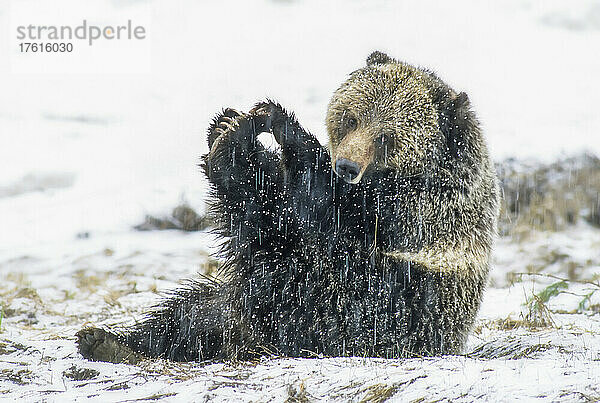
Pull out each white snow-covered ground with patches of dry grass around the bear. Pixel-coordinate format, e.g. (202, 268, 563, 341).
(0, 0, 600, 401)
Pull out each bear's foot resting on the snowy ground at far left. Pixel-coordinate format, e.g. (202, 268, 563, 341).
(76, 327, 144, 364)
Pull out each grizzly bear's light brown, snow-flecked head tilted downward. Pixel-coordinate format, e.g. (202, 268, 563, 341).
(326, 52, 466, 183)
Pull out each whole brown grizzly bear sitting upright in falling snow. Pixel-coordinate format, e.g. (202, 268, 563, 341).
(78, 52, 499, 362)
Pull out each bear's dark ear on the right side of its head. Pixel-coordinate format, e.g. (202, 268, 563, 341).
(438, 92, 473, 158)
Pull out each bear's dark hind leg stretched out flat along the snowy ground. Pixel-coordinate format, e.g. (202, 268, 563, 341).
(77, 282, 223, 364)
